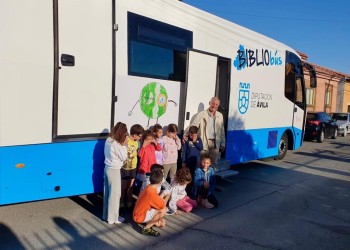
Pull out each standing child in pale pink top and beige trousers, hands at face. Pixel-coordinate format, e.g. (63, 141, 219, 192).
(163, 123, 181, 181)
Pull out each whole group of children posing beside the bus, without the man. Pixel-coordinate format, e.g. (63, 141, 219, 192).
(103, 122, 218, 236)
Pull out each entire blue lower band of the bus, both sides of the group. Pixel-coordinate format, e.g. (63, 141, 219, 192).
(0, 127, 302, 205)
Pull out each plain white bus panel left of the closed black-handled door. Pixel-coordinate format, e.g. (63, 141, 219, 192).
(0, 0, 54, 146)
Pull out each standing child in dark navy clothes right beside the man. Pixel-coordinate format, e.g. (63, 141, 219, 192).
(182, 126, 203, 176)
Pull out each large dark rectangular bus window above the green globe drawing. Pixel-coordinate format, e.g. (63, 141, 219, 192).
(128, 12, 193, 82)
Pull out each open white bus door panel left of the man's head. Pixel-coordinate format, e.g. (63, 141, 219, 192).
(184, 50, 218, 129)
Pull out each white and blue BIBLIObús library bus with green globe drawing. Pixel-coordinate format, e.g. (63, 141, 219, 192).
(0, 0, 316, 205)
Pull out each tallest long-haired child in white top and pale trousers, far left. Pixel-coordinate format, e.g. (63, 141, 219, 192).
(103, 122, 128, 224)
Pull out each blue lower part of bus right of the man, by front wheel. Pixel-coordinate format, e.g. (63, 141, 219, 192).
(225, 127, 302, 164)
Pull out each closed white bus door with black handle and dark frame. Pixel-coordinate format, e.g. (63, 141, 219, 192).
(53, 0, 114, 140)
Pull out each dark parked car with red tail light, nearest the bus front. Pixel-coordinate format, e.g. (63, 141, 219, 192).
(305, 112, 338, 142)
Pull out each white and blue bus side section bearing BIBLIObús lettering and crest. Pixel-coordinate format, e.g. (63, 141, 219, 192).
(226, 40, 302, 164)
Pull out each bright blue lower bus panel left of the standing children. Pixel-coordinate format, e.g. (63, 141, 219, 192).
(0, 140, 105, 205)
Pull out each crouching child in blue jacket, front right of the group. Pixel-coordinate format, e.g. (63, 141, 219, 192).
(194, 155, 218, 208)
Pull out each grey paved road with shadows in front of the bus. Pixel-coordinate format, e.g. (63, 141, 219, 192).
(0, 137, 350, 250)
